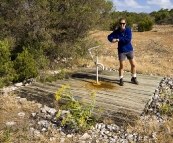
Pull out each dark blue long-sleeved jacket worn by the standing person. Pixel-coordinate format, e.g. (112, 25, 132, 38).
(108, 26, 133, 53)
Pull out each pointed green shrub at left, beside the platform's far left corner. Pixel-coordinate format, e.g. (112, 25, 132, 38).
(14, 47, 38, 81)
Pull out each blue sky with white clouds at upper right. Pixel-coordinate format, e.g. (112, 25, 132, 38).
(111, 0, 173, 13)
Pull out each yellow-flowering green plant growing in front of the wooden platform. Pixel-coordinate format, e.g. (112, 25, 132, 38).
(55, 85, 96, 131)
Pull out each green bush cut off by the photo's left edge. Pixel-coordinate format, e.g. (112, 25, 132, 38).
(0, 39, 14, 87)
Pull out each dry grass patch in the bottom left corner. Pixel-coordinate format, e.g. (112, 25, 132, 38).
(0, 94, 59, 143)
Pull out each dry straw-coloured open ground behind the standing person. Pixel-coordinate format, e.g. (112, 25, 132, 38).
(89, 25, 173, 76)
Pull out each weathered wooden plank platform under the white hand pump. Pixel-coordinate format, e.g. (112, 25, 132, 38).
(17, 69, 163, 125)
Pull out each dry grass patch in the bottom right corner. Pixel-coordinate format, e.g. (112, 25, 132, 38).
(127, 117, 173, 143)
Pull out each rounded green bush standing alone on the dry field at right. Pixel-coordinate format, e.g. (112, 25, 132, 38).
(138, 17, 154, 32)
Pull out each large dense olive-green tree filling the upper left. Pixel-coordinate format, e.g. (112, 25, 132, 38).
(0, 0, 113, 61)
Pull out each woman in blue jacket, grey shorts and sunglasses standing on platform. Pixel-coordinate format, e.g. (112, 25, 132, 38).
(108, 18, 138, 86)
